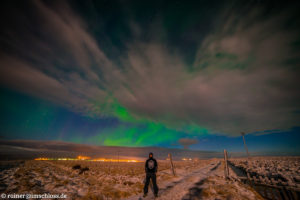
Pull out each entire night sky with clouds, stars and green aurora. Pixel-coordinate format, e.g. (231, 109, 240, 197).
(0, 0, 300, 155)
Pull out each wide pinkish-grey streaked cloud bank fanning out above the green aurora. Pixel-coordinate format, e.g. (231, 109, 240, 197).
(0, 1, 300, 136)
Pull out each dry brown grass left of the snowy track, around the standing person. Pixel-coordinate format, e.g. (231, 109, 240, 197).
(0, 160, 216, 199)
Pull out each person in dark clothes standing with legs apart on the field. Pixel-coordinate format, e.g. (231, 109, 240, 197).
(144, 152, 158, 197)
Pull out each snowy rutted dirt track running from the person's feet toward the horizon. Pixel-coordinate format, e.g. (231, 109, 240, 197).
(128, 160, 263, 200)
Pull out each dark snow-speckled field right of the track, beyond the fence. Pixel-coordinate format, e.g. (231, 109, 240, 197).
(230, 157, 300, 199)
